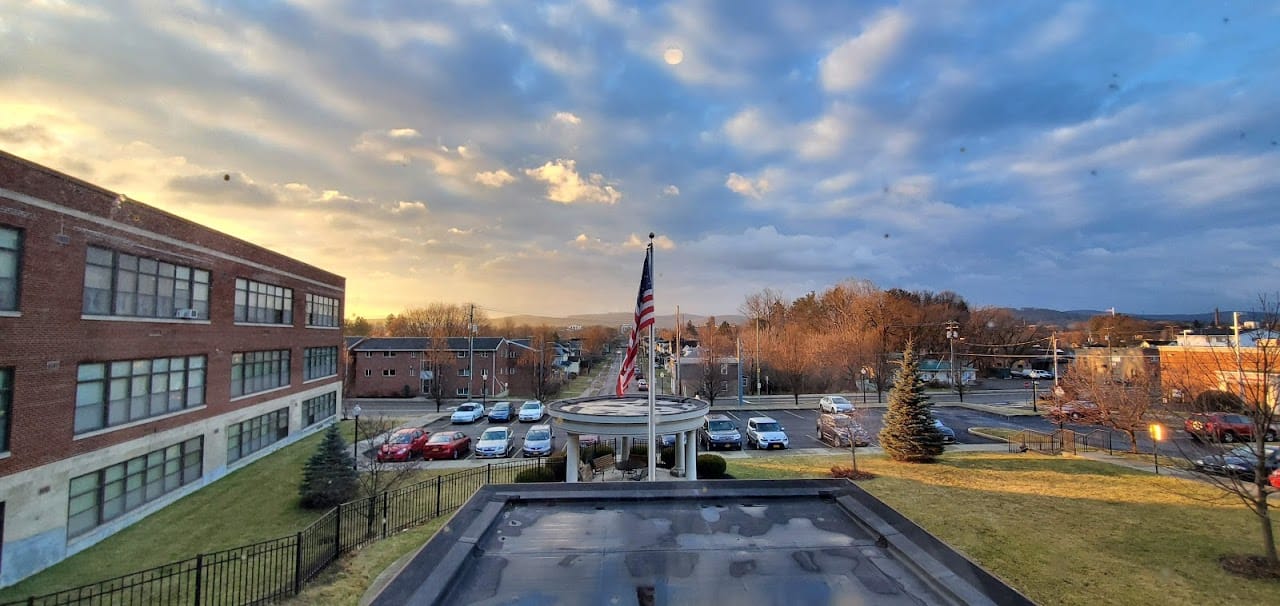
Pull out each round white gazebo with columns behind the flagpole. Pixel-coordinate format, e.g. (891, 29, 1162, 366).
(548, 393, 710, 483)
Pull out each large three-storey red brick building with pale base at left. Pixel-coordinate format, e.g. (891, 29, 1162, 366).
(0, 152, 346, 586)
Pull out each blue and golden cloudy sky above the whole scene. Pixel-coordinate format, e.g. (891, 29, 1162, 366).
(0, 0, 1280, 316)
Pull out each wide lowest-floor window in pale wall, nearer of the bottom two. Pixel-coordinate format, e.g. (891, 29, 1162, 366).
(67, 438, 205, 537)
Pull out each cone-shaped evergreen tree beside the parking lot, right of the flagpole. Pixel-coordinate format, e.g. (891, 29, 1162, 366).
(879, 341, 942, 463)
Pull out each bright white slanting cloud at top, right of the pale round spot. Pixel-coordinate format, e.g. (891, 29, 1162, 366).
(819, 10, 911, 92)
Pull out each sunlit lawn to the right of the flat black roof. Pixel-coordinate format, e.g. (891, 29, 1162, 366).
(728, 452, 1280, 605)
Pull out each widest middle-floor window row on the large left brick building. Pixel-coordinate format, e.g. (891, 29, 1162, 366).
(76, 356, 205, 433)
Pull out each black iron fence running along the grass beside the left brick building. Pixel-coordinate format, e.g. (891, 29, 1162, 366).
(0, 459, 544, 606)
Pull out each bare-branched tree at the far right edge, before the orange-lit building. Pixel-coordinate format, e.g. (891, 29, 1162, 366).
(1162, 293, 1280, 570)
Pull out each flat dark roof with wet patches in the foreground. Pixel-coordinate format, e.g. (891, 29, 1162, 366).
(364, 479, 1033, 606)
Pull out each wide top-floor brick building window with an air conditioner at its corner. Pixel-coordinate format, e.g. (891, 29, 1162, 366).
(82, 246, 209, 319)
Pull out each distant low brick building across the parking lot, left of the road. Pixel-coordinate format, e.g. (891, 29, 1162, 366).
(347, 337, 535, 398)
